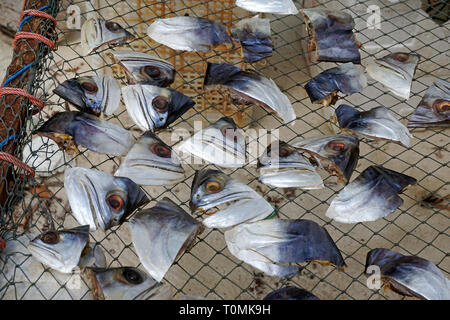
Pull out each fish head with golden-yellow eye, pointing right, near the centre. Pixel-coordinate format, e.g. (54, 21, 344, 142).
(189, 169, 255, 212)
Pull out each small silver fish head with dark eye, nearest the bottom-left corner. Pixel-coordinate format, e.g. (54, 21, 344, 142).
(28, 225, 89, 273)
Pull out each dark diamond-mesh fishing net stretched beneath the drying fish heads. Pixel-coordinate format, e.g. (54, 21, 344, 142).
(0, 0, 450, 299)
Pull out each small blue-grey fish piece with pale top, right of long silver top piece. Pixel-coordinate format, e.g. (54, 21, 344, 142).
(230, 16, 273, 63)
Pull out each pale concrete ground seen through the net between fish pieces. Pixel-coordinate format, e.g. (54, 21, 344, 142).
(0, 0, 450, 299)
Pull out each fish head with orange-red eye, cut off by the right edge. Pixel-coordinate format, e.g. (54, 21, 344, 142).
(408, 79, 450, 128)
